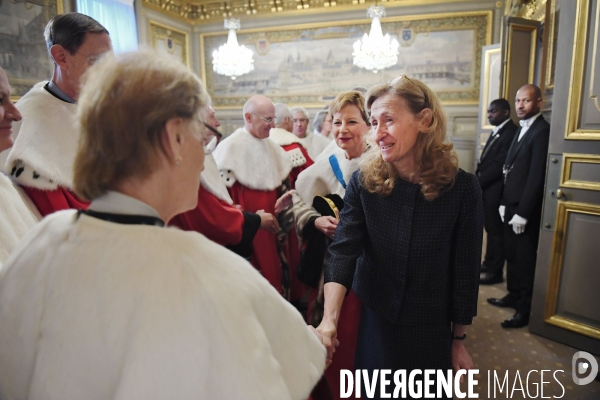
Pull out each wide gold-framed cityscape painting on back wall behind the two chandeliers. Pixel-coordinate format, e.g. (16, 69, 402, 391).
(200, 11, 492, 108)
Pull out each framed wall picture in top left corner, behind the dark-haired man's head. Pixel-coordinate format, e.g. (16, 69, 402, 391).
(0, 0, 63, 101)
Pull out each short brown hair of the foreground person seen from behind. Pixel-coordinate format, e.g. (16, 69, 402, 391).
(74, 51, 210, 200)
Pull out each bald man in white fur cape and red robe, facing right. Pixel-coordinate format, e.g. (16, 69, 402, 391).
(213, 95, 292, 293)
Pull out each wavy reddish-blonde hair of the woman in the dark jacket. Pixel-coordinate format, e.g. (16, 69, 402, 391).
(360, 75, 458, 201)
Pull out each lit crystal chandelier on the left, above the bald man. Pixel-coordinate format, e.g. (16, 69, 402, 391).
(213, 18, 254, 79)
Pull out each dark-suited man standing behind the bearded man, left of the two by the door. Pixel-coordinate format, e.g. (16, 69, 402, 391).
(476, 99, 517, 285)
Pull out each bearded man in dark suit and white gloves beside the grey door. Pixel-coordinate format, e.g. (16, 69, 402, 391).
(488, 84, 550, 328)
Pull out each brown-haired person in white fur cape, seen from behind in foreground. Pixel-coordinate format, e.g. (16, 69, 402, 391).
(0, 52, 326, 400)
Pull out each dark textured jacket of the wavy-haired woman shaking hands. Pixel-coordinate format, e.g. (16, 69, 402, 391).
(325, 170, 483, 326)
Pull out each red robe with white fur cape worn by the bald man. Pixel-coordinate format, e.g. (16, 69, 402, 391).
(214, 128, 292, 293)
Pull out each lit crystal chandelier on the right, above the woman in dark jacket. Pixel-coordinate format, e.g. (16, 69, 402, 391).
(352, 6, 400, 73)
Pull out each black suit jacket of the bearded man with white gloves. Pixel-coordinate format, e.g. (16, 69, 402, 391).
(502, 115, 550, 220)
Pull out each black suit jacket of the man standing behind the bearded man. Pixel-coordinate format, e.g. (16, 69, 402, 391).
(475, 120, 519, 205)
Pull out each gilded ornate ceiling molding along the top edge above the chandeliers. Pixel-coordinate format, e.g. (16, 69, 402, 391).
(142, 0, 486, 25)
